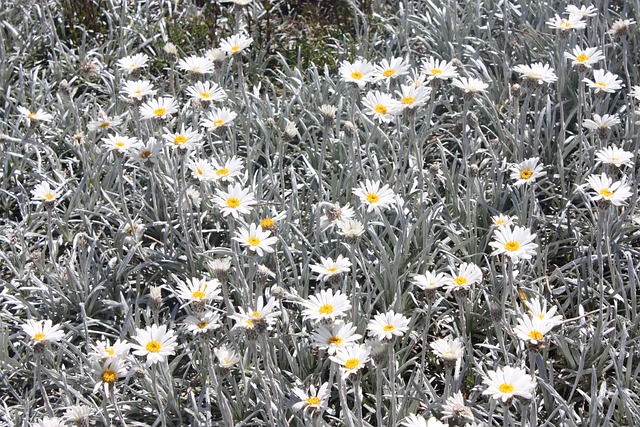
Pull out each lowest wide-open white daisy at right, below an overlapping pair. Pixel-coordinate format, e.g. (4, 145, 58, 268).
(482, 366, 536, 403)
